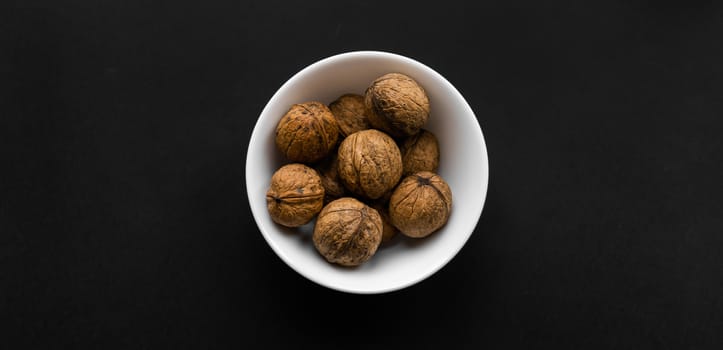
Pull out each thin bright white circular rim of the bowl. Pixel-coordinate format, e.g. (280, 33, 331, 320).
(245, 50, 489, 294)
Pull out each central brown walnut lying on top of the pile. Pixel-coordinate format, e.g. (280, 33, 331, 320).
(338, 129, 402, 199)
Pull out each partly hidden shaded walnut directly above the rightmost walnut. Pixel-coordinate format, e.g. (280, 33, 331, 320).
(399, 129, 439, 176)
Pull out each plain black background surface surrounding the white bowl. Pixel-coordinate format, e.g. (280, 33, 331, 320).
(0, 0, 723, 349)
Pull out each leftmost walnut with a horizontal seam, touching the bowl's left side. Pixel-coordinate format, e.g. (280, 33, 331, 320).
(266, 163, 324, 227)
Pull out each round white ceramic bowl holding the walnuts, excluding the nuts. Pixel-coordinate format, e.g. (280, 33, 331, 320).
(246, 51, 489, 294)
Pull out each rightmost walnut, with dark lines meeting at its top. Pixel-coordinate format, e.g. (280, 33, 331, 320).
(389, 171, 452, 238)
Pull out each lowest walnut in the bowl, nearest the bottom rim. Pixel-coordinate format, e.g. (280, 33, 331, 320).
(312, 197, 382, 266)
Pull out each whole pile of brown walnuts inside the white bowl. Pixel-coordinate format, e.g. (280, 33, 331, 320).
(266, 73, 452, 266)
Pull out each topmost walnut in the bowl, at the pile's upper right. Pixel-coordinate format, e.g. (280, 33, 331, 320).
(364, 73, 429, 137)
